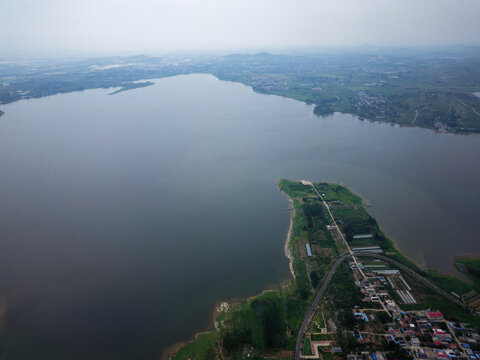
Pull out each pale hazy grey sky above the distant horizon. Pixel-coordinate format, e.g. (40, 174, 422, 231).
(0, 0, 480, 56)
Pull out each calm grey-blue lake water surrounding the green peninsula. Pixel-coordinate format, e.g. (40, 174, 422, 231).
(0, 75, 480, 359)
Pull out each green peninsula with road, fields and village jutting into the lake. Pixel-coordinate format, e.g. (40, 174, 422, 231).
(171, 180, 480, 360)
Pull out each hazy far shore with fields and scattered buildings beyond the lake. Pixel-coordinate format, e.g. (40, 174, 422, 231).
(0, 46, 480, 133)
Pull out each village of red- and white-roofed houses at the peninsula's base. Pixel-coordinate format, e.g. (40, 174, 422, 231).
(301, 249, 480, 360)
